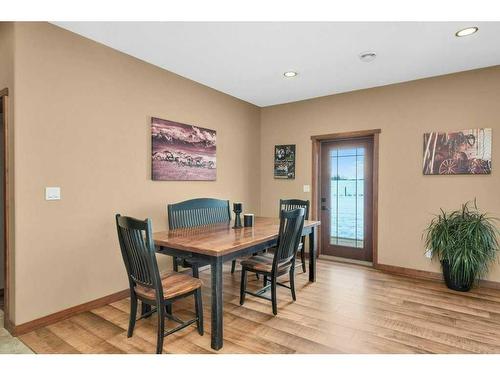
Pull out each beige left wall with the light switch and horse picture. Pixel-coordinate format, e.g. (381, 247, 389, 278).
(10, 23, 260, 324)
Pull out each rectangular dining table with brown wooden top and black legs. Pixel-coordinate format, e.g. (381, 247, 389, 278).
(153, 217, 320, 350)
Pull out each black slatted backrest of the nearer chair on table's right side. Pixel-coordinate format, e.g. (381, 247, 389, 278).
(273, 207, 305, 272)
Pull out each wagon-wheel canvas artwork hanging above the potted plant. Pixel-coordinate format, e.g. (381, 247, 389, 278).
(423, 128, 491, 174)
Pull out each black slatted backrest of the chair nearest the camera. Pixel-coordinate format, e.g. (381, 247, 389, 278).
(116, 214, 163, 298)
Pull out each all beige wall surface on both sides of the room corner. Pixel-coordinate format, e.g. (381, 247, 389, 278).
(0, 23, 500, 324)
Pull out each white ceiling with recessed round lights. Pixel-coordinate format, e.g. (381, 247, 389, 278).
(55, 22, 500, 107)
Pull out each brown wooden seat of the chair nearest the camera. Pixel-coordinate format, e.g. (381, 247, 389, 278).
(134, 272, 203, 300)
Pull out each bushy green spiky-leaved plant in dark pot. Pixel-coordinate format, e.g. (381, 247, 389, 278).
(424, 200, 499, 292)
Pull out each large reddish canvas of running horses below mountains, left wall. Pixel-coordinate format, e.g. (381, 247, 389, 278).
(151, 117, 216, 181)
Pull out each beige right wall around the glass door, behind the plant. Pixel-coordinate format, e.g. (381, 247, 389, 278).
(261, 66, 500, 281)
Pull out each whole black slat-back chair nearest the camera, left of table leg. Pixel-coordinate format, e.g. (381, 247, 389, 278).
(116, 214, 203, 354)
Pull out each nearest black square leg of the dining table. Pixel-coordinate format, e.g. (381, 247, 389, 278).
(210, 257, 224, 350)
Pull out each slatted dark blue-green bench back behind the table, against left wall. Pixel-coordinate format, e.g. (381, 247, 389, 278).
(167, 198, 231, 229)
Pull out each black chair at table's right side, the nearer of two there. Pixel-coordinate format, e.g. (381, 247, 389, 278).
(240, 208, 305, 315)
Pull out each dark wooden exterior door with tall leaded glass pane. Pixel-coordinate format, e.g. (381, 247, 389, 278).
(319, 137, 373, 261)
